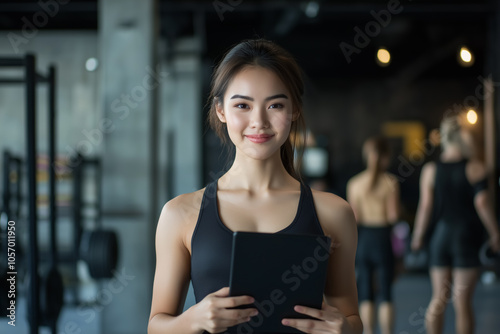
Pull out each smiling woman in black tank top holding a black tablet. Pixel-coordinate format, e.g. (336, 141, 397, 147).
(148, 40, 362, 334)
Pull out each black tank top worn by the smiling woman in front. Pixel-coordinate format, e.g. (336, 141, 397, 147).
(191, 180, 324, 303)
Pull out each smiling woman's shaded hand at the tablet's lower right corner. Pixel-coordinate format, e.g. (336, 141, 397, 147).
(281, 302, 350, 334)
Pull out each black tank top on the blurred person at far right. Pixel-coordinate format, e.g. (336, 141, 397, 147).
(433, 159, 485, 227)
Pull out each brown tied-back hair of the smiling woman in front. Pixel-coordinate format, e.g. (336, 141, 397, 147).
(207, 39, 305, 180)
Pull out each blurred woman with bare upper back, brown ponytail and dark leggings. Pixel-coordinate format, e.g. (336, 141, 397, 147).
(347, 137, 399, 334)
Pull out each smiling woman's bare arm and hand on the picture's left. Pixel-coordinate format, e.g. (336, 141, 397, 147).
(148, 193, 257, 334)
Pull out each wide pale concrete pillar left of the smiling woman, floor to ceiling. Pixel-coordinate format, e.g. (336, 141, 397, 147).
(97, 0, 159, 334)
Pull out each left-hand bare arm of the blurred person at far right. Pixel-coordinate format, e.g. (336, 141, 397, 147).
(412, 162, 436, 250)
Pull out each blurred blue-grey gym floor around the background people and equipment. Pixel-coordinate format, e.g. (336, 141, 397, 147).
(0, 274, 500, 334)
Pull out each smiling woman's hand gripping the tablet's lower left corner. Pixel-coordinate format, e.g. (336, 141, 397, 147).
(191, 287, 258, 333)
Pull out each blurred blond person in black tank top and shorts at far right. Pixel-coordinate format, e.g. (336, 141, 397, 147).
(412, 116, 500, 334)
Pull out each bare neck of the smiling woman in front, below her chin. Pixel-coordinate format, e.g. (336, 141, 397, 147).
(220, 150, 297, 193)
